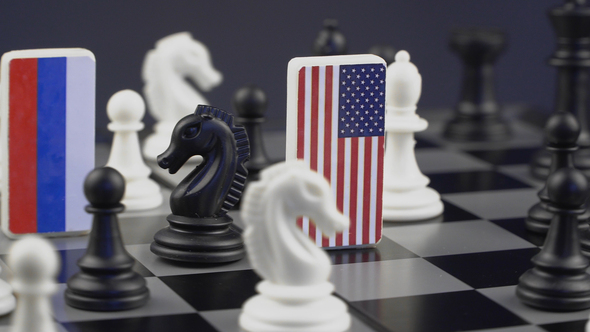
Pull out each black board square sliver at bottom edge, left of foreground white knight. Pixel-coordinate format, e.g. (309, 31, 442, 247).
(62, 313, 217, 332)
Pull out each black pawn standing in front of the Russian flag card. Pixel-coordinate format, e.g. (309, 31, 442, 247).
(65, 167, 149, 311)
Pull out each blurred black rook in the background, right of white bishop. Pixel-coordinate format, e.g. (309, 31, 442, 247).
(444, 29, 511, 142)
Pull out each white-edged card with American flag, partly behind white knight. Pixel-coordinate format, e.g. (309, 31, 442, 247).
(286, 55, 387, 248)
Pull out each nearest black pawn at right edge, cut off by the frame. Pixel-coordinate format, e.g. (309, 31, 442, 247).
(516, 167, 590, 311)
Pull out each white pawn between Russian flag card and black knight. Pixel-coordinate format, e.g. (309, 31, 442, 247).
(106, 90, 163, 211)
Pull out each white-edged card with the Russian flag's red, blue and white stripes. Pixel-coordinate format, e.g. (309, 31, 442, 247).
(0, 48, 96, 238)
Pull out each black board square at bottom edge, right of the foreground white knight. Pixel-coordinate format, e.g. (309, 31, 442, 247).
(350, 290, 527, 332)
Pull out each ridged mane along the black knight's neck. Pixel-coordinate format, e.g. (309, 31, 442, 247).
(195, 105, 250, 214)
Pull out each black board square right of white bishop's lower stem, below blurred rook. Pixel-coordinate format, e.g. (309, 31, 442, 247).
(428, 171, 532, 194)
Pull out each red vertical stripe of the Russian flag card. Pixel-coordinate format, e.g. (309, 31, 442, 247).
(4, 59, 37, 234)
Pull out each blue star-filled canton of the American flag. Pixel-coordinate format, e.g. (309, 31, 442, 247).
(338, 64, 385, 138)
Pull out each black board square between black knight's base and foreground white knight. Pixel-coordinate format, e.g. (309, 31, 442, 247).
(159, 270, 261, 311)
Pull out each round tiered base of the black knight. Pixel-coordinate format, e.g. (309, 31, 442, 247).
(150, 214, 246, 264)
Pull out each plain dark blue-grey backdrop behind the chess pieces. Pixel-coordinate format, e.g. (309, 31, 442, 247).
(0, 0, 563, 141)
